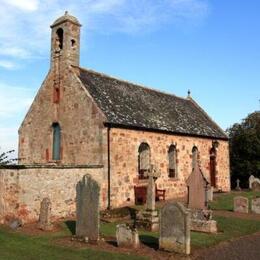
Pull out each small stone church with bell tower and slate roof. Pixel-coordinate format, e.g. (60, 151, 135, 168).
(15, 12, 230, 217)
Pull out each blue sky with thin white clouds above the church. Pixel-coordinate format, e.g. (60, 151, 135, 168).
(0, 0, 260, 150)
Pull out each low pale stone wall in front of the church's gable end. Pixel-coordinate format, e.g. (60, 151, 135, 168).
(0, 166, 103, 223)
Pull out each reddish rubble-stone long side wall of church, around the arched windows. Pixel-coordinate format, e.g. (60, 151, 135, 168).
(110, 128, 230, 207)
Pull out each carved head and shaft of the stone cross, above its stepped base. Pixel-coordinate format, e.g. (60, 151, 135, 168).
(146, 165, 161, 211)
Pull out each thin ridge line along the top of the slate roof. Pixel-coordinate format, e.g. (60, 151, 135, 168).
(71, 65, 189, 101)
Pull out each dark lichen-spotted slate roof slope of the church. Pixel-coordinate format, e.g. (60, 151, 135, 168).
(78, 68, 227, 139)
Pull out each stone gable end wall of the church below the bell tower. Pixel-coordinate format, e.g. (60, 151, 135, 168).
(19, 63, 107, 165)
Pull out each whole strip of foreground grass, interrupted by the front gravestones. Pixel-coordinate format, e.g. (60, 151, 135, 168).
(0, 213, 260, 260)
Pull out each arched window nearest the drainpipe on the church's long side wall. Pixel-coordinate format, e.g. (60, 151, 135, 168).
(138, 143, 151, 179)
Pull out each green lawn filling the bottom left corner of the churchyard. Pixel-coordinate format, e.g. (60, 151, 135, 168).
(0, 225, 147, 260)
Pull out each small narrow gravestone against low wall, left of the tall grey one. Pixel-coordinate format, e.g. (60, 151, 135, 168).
(38, 198, 53, 231)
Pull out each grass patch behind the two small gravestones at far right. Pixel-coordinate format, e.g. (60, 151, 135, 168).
(210, 191, 260, 211)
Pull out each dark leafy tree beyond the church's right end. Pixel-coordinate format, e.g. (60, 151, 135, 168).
(228, 111, 260, 188)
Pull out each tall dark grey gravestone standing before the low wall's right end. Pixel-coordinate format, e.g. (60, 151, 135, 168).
(76, 174, 100, 242)
